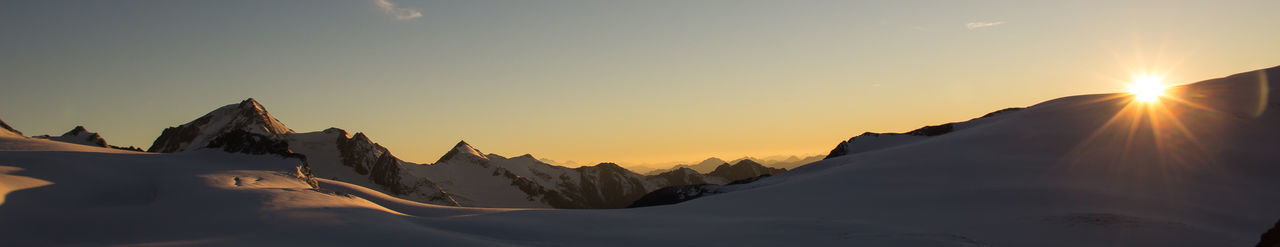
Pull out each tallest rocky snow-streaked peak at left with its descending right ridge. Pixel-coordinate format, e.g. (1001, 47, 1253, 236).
(148, 99, 457, 205)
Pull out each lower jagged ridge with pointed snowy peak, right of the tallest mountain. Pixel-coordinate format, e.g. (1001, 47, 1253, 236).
(412, 142, 783, 209)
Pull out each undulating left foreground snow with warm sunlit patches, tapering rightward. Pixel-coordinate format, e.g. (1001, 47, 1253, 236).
(0, 134, 957, 246)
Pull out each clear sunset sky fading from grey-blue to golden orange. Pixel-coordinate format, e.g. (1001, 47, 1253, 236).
(0, 0, 1280, 165)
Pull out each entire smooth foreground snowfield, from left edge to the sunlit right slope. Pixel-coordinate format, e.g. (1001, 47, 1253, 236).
(0, 69, 1280, 246)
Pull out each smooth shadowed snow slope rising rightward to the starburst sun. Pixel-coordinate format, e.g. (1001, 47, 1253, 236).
(669, 68, 1280, 246)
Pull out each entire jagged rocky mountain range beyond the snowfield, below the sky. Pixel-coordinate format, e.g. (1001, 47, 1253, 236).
(140, 99, 785, 209)
